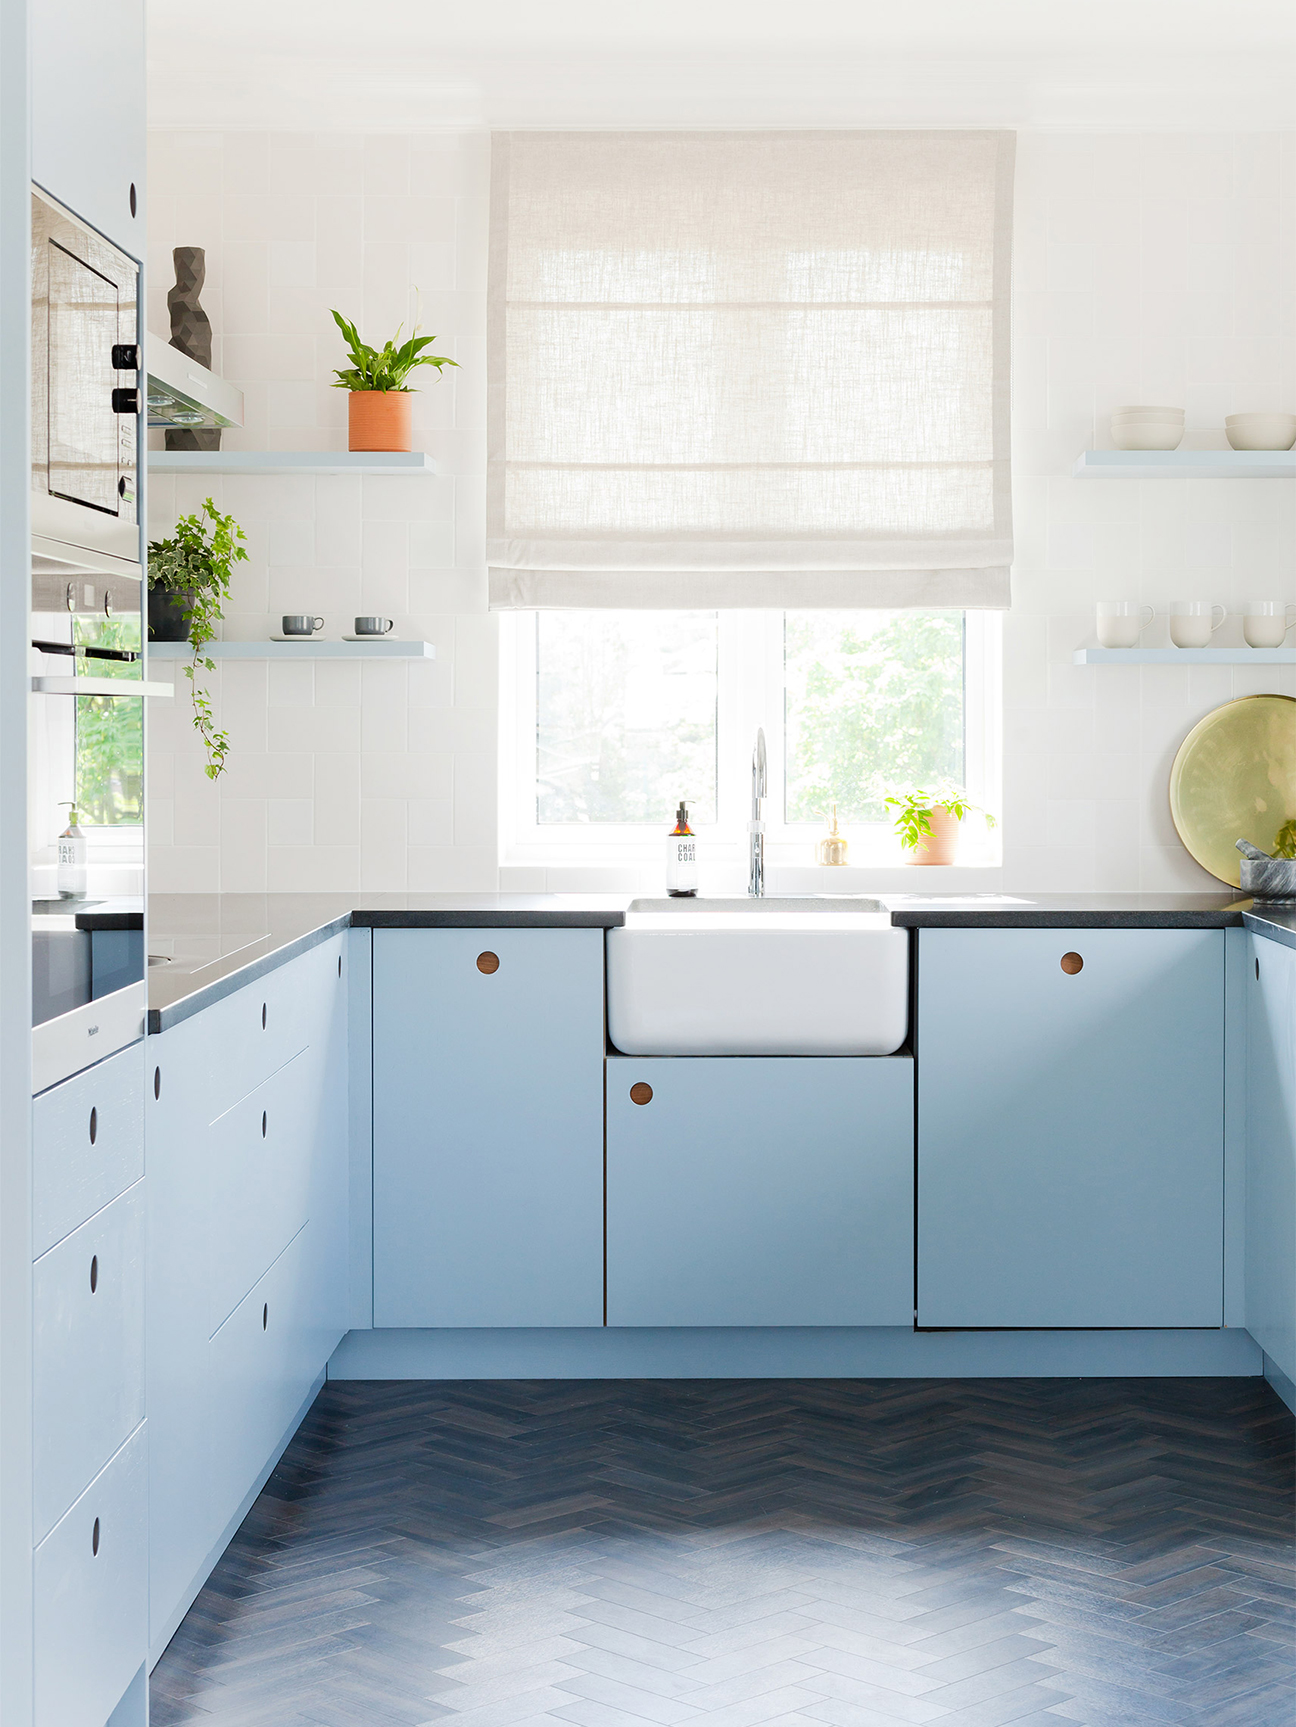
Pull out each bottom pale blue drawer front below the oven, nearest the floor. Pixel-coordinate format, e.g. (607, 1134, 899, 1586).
(33, 1425, 149, 1727)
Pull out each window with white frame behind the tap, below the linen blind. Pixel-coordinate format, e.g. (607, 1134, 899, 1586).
(501, 611, 1001, 867)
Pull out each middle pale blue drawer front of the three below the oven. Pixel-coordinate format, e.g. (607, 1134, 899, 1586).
(31, 1183, 145, 1540)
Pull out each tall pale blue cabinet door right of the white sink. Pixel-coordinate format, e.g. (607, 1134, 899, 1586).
(916, 929, 1223, 1328)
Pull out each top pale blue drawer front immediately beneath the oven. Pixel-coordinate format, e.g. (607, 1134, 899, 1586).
(31, 1043, 145, 1259)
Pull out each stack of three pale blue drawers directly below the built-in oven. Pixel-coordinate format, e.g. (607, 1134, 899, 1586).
(31, 1043, 149, 1727)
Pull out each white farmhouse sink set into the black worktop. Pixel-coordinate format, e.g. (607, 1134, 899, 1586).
(608, 898, 909, 1055)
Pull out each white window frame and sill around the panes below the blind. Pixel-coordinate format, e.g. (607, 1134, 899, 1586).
(499, 611, 1002, 869)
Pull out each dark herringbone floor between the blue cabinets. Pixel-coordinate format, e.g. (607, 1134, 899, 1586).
(152, 1380, 1296, 1727)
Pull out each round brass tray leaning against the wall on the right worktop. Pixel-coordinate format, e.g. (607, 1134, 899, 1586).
(1170, 696, 1296, 888)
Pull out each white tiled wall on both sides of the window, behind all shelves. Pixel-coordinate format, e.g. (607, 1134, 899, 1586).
(150, 133, 1296, 891)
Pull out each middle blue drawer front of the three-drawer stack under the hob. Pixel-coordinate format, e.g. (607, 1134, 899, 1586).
(207, 1050, 323, 1333)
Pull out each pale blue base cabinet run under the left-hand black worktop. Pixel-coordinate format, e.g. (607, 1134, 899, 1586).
(145, 934, 349, 1654)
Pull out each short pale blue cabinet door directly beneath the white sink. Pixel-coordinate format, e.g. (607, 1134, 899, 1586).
(607, 1055, 914, 1325)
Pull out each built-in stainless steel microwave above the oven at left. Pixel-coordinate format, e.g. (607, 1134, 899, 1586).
(31, 190, 143, 579)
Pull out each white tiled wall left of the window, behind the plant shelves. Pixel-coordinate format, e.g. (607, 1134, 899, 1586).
(149, 133, 498, 893)
